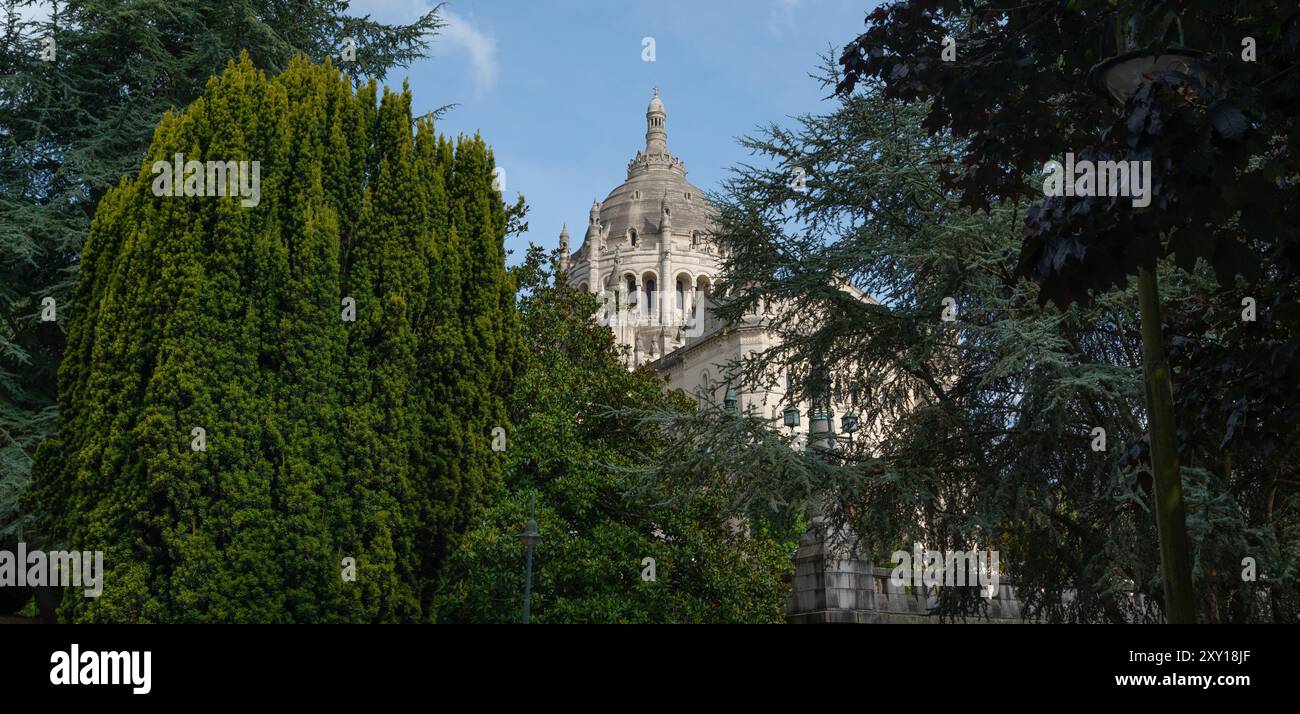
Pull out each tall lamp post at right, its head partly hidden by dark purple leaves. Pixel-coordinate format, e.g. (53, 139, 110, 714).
(1088, 44, 1208, 624)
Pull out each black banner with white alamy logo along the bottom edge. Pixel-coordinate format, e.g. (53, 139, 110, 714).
(0, 626, 1279, 705)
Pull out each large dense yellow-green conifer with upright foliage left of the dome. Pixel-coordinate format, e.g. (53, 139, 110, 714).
(30, 57, 517, 622)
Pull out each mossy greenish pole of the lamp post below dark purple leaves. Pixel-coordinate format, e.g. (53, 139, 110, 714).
(1138, 259, 1196, 624)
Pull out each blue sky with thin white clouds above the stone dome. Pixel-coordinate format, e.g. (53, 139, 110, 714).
(351, 0, 874, 261)
